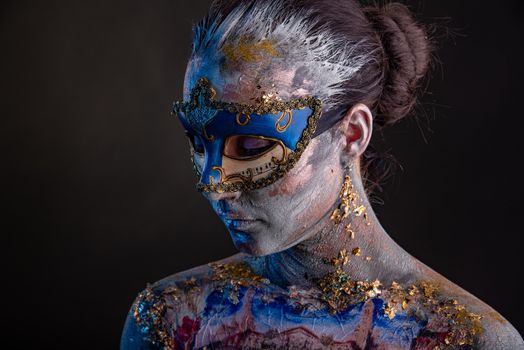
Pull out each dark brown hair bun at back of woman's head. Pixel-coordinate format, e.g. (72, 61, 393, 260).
(364, 3, 432, 124)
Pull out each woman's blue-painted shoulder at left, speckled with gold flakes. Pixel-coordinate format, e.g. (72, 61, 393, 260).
(120, 254, 248, 350)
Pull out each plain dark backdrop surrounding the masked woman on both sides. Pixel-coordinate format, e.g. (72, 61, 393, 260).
(0, 0, 524, 349)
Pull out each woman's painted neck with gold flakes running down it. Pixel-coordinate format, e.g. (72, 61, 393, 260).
(256, 169, 417, 286)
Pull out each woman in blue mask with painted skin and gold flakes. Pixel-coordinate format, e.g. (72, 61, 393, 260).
(122, 0, 524, 349)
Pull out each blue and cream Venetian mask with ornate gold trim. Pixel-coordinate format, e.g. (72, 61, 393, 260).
(173, 78, 321, 192)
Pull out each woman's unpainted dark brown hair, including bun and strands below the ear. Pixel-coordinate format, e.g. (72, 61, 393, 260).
(203, 0, 433, 193)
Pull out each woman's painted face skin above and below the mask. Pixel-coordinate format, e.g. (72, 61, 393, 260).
(184, 55, 350, 255)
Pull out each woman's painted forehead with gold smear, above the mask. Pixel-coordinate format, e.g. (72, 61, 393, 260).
(184, 38, 312, 103)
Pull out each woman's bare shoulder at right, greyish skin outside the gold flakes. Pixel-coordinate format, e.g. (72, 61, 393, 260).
(414, 270, 524, 350)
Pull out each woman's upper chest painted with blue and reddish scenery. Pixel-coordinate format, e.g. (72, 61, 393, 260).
(184, 289, 434, 349)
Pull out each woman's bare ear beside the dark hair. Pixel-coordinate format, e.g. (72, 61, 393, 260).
(339, 103, 373, 157)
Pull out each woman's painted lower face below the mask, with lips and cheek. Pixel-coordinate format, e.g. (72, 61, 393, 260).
(205, 131, 343, 255)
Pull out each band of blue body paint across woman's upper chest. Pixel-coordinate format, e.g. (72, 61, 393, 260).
(197, 287, 427, 349)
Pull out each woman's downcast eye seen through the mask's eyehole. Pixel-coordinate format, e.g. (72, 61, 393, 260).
(224, 135, 277, 159)
